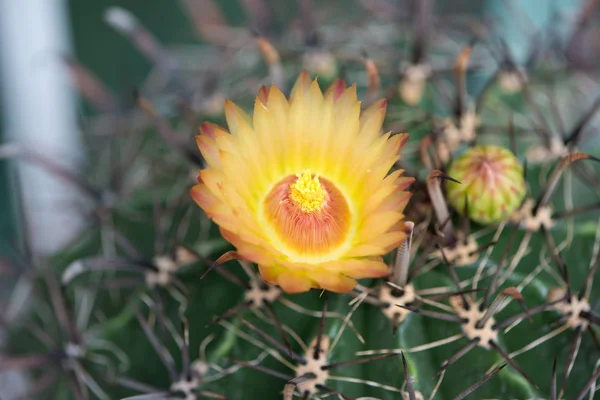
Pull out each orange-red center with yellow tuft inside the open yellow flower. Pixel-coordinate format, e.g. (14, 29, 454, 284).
(264, 171, 350, 256)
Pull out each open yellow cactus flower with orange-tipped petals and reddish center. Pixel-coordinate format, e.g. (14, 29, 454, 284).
(190, 72, 413, 293)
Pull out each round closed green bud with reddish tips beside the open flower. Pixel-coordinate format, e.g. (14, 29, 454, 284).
(446, 146, 525, 224)
